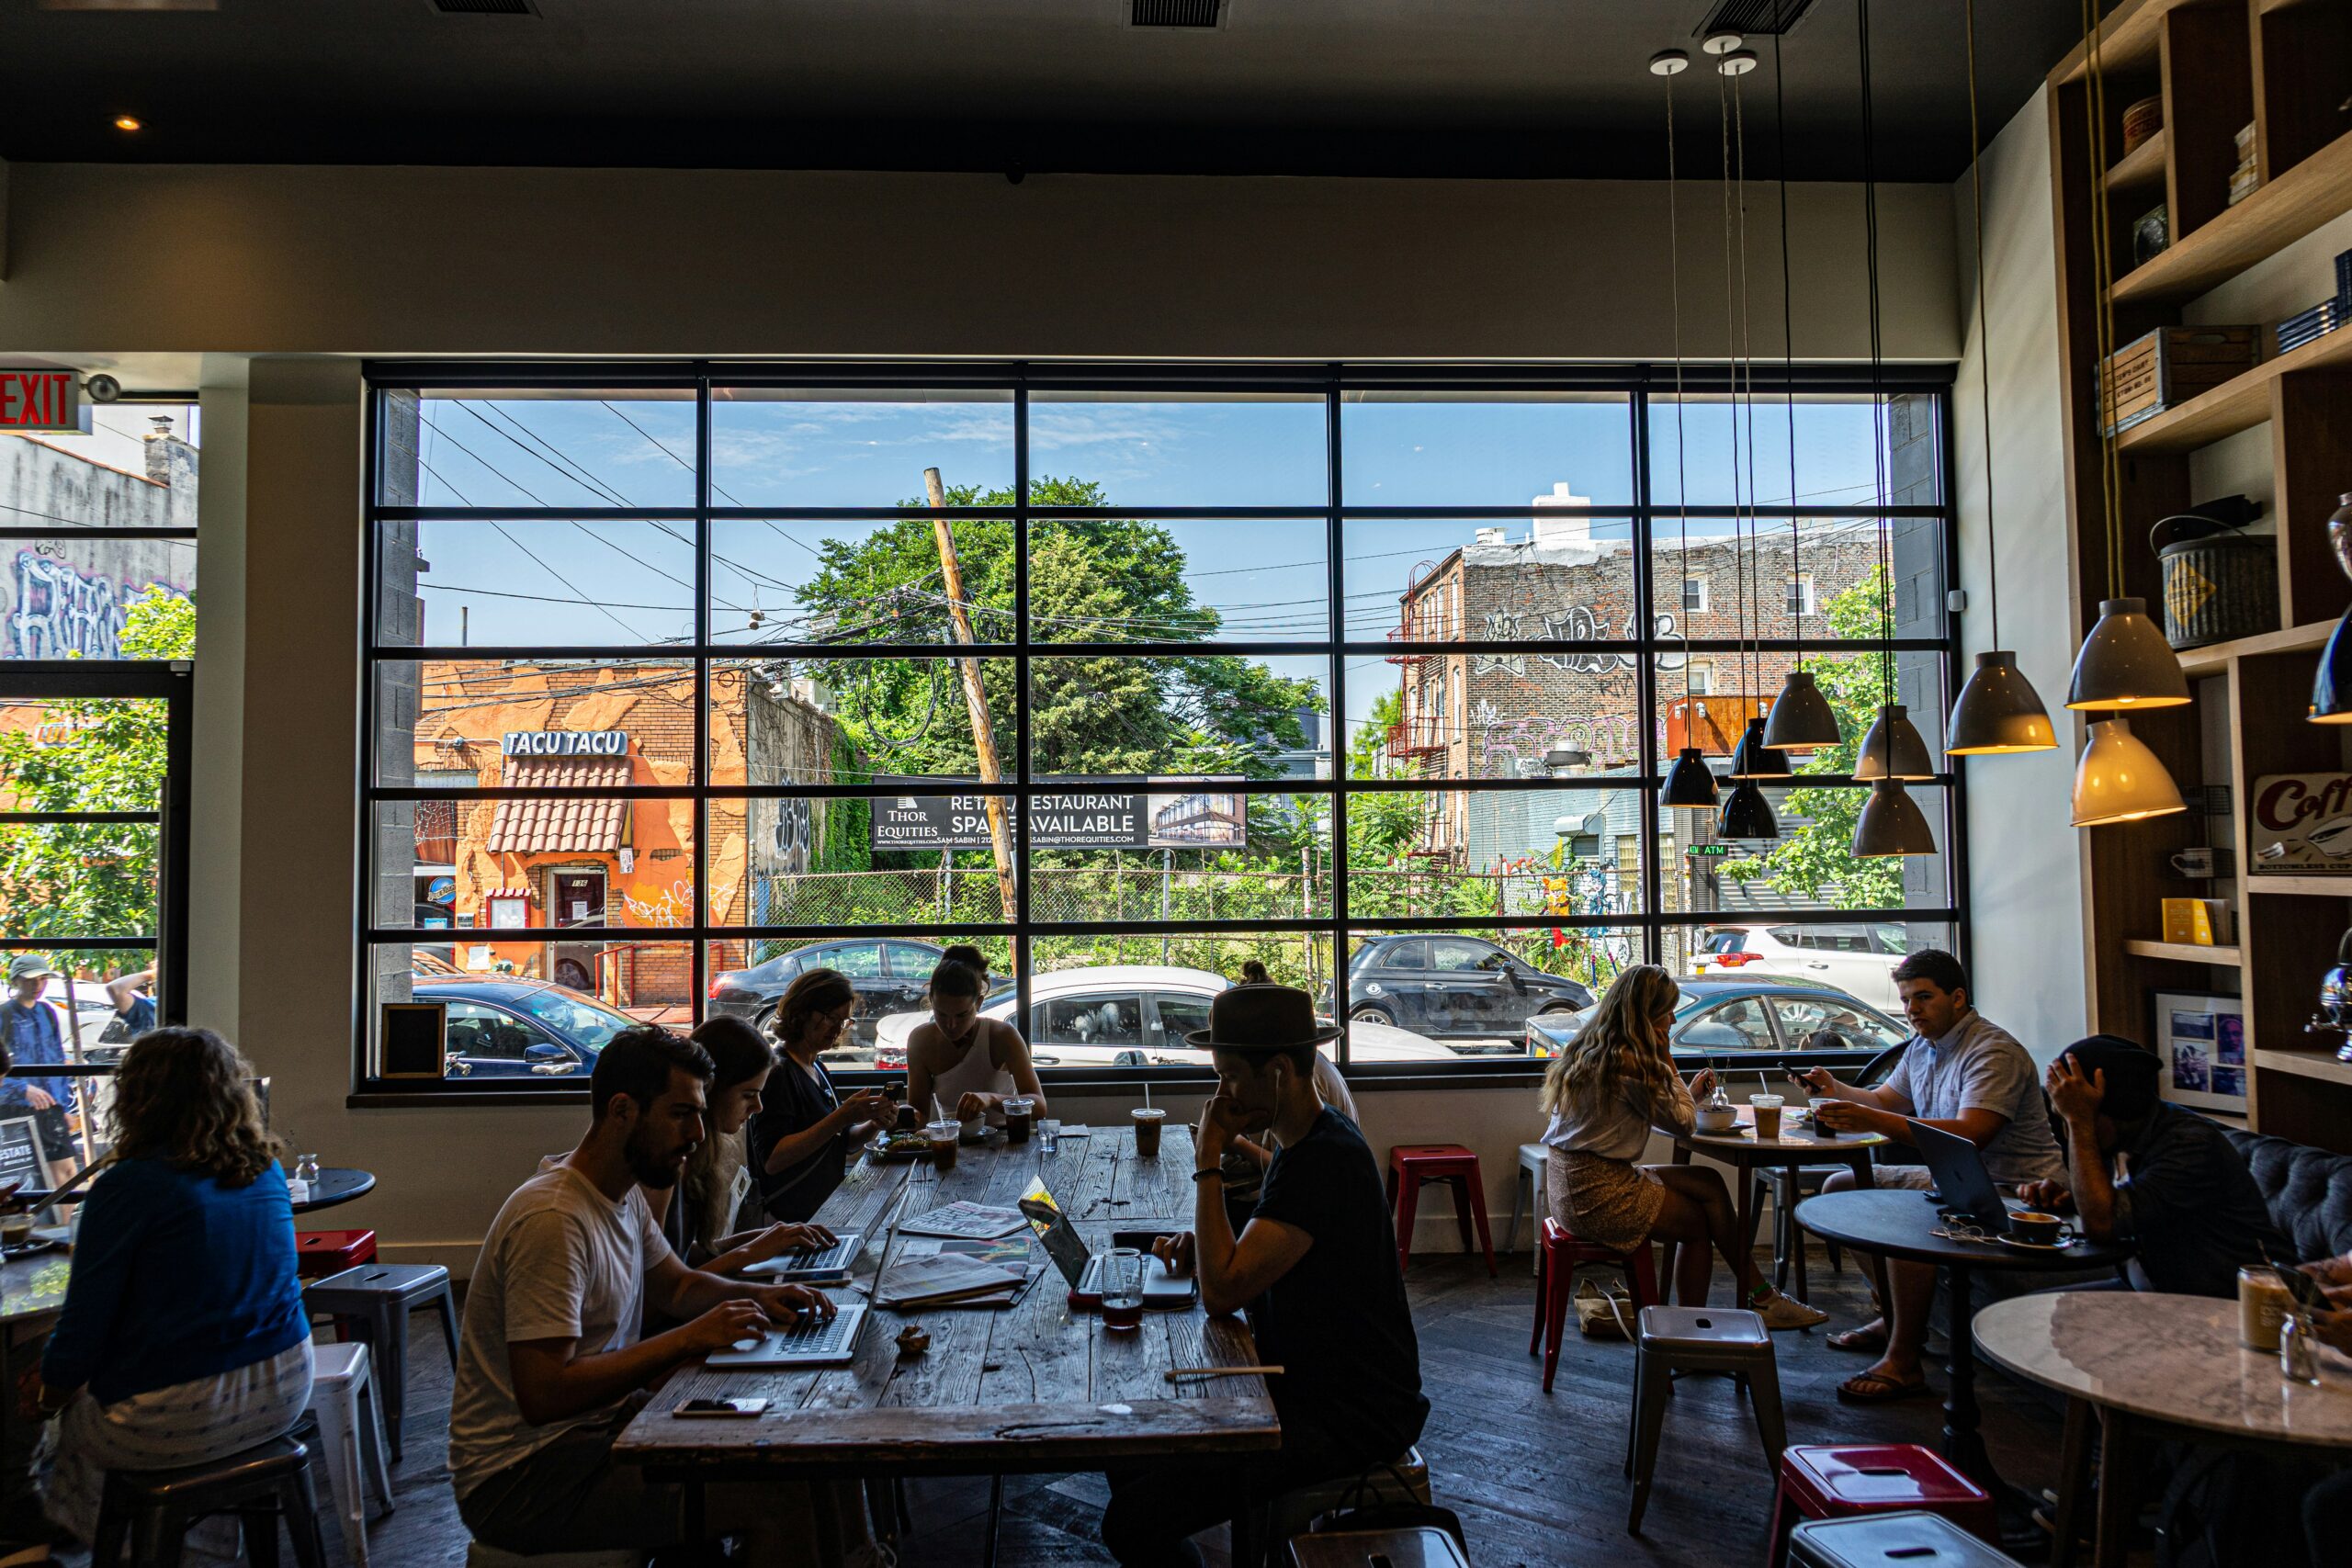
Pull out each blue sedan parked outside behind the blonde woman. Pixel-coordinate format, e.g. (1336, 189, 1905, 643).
(1526, 976, 1910, 1072)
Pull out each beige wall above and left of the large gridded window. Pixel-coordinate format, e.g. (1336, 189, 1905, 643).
(0, 164, 1956, 1267)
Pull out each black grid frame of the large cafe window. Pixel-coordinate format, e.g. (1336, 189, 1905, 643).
(356, 365, 1966, 1093)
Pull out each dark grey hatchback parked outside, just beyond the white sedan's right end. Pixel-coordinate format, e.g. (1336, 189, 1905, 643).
(1348, 933, 1592, 1051)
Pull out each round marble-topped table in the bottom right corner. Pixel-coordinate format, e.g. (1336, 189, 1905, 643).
(1975, 1291, 2352, 1568)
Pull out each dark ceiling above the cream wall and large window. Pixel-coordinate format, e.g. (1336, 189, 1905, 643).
(0, 0, 2079, 181)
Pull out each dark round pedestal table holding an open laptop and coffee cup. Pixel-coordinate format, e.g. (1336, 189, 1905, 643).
(1797, 1187, 2144, 1502)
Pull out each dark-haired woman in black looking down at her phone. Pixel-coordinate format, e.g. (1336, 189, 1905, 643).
(748, 968, 896, 1224)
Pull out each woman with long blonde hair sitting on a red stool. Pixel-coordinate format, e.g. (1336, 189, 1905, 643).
(1543, 964, 1827, 1328)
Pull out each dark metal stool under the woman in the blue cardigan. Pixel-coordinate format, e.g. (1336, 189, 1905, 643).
(89, 1422, 327, 1568)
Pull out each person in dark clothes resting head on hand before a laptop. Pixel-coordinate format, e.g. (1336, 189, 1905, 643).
(2018, 1034, 2293, 1295)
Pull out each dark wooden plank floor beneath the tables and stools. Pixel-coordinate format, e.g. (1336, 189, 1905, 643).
(347, 1253, 2058, 1568)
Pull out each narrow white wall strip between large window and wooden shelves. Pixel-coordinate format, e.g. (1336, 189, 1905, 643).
(1952, 89, 2086, 1058)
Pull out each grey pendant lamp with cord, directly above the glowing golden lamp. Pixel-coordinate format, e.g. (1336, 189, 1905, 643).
(2065, 0, 2189, 719)
